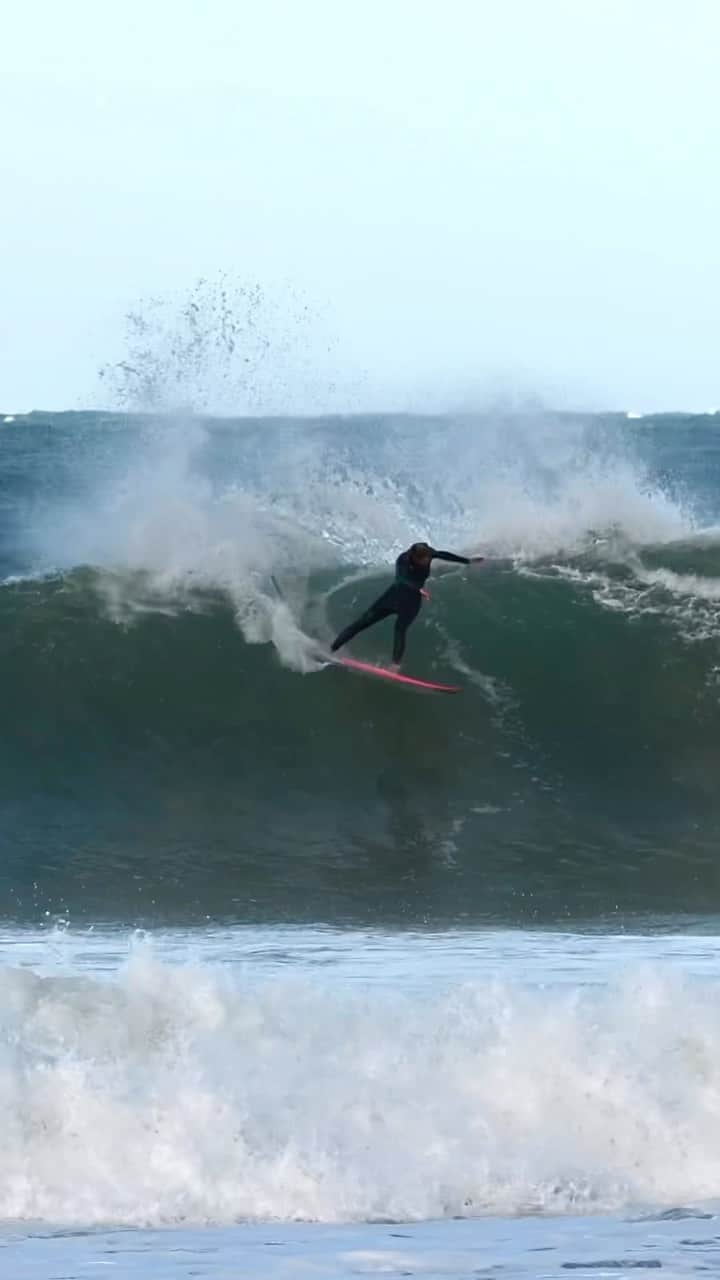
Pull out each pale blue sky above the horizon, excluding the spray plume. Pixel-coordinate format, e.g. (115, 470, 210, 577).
(0, 0, 720, 410)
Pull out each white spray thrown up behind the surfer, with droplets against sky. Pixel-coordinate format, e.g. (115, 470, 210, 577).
(37, 276, 688, 671)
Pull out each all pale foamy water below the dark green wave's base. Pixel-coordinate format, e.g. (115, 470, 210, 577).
(0, 927, 720, 1275)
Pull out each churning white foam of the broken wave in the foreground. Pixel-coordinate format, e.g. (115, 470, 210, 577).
(0, 950, 720, 1226)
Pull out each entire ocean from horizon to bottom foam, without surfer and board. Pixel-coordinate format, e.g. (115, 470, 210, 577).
(0, 413, 720, 1277)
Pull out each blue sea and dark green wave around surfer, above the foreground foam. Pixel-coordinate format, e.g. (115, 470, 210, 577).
(0, 415, 720, 922)
